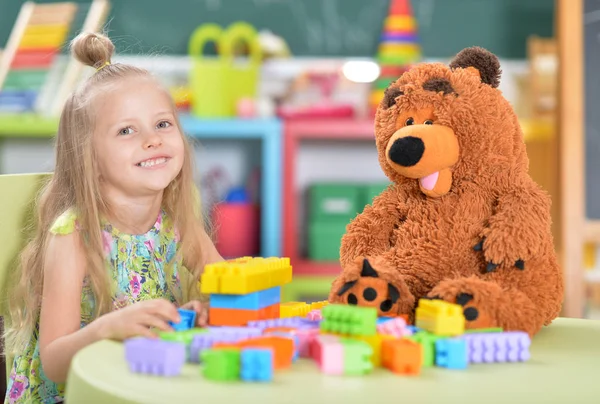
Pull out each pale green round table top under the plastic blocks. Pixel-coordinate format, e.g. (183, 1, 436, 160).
(66, 318, 600, 404)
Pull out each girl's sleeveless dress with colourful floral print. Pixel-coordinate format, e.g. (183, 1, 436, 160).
(4, 211, 181, 404)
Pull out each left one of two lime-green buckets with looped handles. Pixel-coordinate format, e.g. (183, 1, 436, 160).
(188, 24, 232, 118)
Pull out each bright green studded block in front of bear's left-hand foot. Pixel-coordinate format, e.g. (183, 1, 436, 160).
(320, 304, 377, 336)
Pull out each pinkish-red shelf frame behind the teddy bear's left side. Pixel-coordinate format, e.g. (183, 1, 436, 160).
(283, 119, 375, 277)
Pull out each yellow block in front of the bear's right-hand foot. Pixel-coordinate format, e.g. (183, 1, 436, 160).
(415, 299, 465, 337)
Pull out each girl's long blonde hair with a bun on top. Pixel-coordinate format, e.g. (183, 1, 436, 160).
(5, 33, 204, 354)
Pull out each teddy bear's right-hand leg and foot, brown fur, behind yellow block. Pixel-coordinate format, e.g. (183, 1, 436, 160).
(428, 254, 563, 336)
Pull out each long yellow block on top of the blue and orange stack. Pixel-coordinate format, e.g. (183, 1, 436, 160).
(200, 257, 292, 295)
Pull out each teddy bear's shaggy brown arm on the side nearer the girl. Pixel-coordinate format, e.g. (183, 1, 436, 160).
(340, 187, 405, 268)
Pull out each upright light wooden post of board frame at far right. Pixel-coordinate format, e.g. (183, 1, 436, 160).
(556, 0, 584, 318)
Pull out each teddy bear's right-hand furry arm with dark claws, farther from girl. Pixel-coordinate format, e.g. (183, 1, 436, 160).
(476, 184, 551, 272)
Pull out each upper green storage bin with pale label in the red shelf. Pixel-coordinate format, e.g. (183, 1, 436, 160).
(309, 183, 363, 222)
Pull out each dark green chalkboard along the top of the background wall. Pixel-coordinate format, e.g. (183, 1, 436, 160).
(0, 0, 554, 58)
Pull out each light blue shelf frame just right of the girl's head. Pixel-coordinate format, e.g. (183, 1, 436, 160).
(180, 115, 282, 257)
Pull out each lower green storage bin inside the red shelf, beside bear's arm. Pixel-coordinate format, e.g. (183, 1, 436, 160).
(308, 220, 349, 261)
